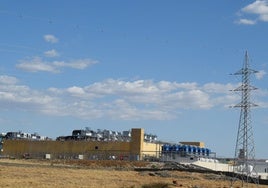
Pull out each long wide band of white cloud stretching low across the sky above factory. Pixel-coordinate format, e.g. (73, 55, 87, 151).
(0, 75, 268, 120)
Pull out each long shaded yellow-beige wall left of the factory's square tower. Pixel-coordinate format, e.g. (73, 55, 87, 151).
(3, 140, 130, 159)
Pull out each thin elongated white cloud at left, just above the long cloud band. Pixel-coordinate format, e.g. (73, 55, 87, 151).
(16, 57, 98, 73)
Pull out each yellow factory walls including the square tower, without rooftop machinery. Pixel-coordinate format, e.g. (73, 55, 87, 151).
(3, 128, 161, 160)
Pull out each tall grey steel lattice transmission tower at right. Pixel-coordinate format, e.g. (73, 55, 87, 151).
(232, 51, 259, 187)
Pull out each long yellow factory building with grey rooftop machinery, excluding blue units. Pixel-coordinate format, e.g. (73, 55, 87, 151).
(2, 128, 162, 160)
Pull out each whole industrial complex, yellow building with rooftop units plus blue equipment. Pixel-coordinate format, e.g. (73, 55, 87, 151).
(0, 128, 268, 180)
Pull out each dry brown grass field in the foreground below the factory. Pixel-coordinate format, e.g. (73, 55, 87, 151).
(0, 159, 268, 188)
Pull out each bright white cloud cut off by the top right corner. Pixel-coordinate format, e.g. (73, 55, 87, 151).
(236, 0, 268, 25)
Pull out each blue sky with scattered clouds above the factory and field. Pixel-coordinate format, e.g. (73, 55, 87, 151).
(0, 0, 268, 159)
